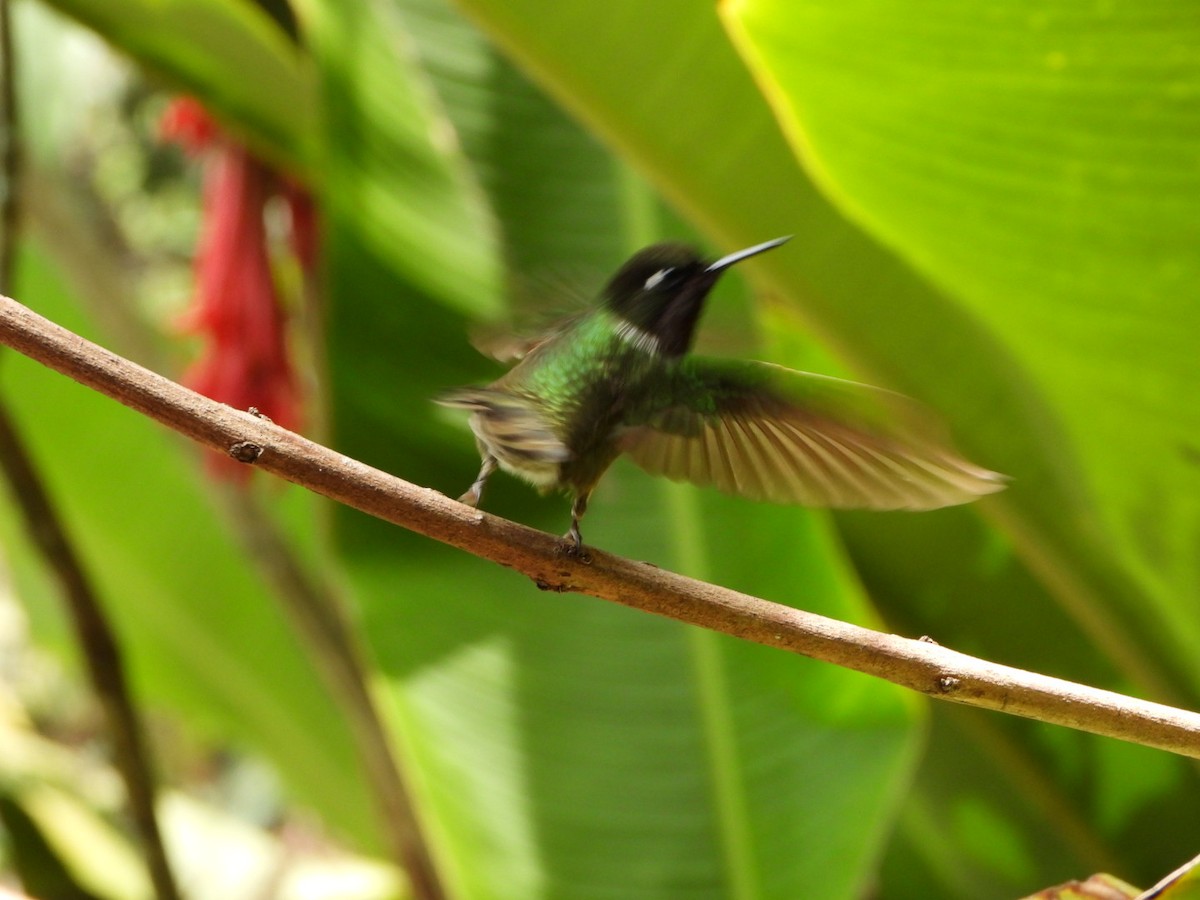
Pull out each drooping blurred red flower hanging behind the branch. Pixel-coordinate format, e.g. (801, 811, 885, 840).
(161, 98, 317, 475)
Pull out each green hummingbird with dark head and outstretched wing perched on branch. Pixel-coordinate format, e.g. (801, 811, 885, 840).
(436, 238, 1007, 556)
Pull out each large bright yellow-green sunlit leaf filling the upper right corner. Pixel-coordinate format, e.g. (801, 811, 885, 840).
(725, 0, 1200, 696)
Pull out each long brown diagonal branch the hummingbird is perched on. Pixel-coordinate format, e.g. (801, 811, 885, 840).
(0, 298, 1200, 758)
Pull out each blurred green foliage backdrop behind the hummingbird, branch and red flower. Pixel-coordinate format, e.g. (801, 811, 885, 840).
(0, 0, 1200, 900)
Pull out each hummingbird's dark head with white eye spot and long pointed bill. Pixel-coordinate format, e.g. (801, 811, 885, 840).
(604, 236, 790, 356)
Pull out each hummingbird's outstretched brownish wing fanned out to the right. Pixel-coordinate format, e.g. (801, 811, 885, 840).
(622, 358, 1007, 510)
